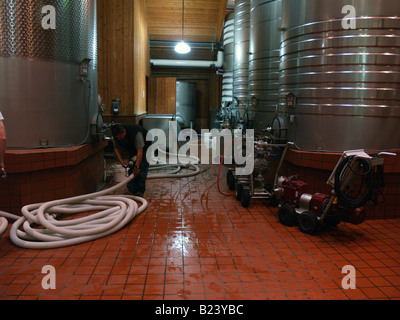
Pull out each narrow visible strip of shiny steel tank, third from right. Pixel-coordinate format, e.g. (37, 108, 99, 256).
(233, 0, 250, 119)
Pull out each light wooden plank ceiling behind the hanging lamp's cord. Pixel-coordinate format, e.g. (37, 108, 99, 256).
(145, 0, 228, 43)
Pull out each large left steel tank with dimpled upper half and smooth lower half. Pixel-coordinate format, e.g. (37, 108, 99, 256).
(0, 0, 98, 148)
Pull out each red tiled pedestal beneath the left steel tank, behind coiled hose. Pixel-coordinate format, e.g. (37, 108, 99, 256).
(0, 143, 105, 215)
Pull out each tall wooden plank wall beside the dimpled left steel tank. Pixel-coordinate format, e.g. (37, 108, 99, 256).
(98, 0, 150, 118)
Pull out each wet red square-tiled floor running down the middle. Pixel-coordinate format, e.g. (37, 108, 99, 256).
(0, 166, 400, 300)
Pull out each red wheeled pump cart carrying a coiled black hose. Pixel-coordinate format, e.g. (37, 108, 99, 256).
(274, 150, 395, 234)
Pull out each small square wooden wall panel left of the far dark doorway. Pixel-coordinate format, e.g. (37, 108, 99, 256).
(148, 78, 176, 114)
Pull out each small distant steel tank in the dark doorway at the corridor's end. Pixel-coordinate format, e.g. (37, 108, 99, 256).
(176, 81, 197, 129)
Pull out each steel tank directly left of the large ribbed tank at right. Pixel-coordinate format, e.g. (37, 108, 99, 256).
(249, 0, 282, 134)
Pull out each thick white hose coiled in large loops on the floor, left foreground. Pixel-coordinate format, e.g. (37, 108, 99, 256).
(0, 175, 147, 249)
